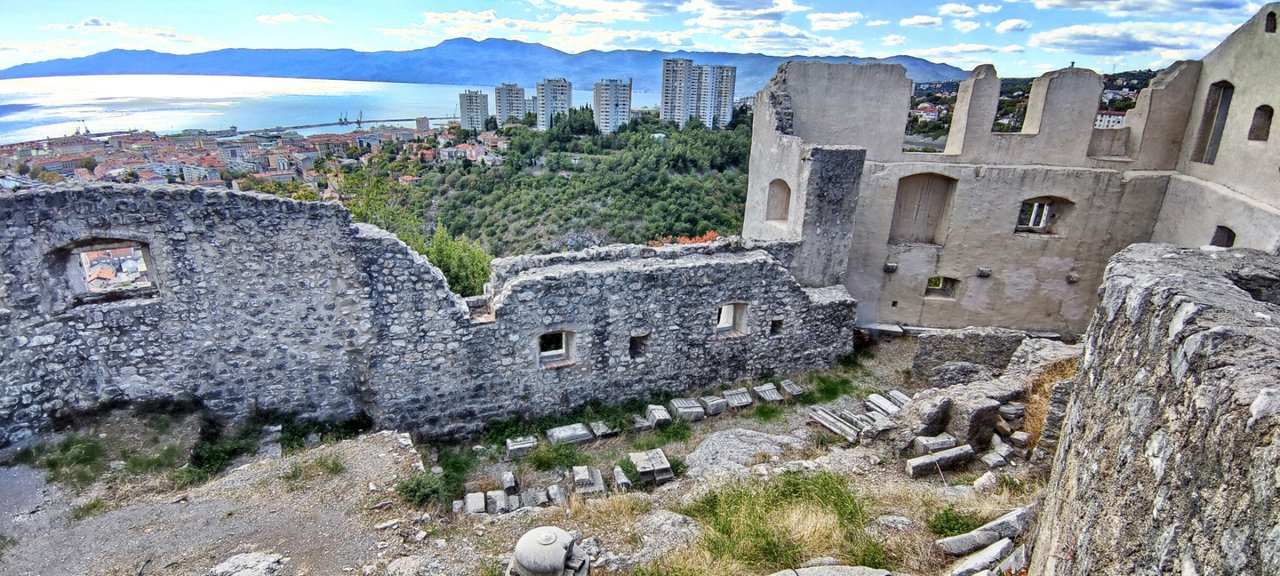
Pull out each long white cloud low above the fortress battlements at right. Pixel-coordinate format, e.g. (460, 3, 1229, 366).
(1028, 22, 1236, 67)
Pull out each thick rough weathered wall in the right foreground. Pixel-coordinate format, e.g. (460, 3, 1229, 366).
(1030, 244, 1280, 576)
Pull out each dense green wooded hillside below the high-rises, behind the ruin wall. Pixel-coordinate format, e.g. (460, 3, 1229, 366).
(247, 108, 751, 294)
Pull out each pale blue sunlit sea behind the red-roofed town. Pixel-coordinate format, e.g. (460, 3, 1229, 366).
(0, 74, 658, 145)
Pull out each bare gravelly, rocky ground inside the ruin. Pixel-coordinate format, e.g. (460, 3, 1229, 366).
(0, 338, 1059, 576)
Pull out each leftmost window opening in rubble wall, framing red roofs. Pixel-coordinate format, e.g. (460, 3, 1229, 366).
(67, 241, 157, 302)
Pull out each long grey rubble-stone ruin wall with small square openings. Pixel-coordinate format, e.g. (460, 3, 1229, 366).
(0, 186, 855, 445)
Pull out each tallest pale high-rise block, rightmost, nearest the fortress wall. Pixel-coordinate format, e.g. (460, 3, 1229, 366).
(662, 58, 737, 128)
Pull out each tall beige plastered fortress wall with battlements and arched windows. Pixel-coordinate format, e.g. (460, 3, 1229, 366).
(744, 4, 1280, 335)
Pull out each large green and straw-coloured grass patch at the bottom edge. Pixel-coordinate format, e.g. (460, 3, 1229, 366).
(670, 472, 888, 576)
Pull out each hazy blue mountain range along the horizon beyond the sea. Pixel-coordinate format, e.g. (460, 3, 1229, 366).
(0, 38, 968, 96)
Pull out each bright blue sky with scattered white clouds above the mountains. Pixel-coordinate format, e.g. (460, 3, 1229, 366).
(0, 0, 1261, 77)
